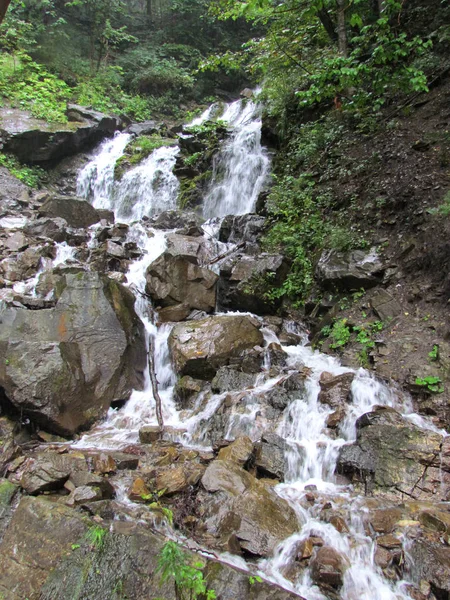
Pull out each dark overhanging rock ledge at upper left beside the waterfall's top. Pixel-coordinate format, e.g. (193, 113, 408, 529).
(0, 106, 121, 164)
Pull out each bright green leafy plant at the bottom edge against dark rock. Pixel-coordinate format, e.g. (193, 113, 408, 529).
(157, 541, 216, 600)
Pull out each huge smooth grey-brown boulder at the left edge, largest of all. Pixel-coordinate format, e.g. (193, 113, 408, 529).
(0, 269, 146, 435)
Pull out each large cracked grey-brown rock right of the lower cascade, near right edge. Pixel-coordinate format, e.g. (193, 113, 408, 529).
(338, 407, 442, 497)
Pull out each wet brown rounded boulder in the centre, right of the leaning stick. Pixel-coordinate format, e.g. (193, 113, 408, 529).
(169, 315, 263, 379)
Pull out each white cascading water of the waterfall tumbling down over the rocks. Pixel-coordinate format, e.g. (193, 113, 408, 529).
(68, 96, 442, 600)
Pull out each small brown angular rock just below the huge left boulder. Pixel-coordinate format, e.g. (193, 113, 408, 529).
(19, 452, 87, 494)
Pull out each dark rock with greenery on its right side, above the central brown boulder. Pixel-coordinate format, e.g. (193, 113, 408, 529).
(217, 254, 289, 314)
